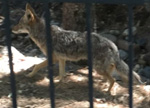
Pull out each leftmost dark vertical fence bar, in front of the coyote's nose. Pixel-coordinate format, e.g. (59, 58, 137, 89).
(3, 0, 17, 108)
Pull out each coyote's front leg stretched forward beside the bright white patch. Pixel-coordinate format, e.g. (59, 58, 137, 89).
(27, 60, 48, 77)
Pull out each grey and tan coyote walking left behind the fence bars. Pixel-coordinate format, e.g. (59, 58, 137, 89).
(12, 4, 142, 92)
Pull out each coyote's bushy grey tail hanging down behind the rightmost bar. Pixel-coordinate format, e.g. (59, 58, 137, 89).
(116, 58, 143, 84)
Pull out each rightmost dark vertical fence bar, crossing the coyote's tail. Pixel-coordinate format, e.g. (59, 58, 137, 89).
(128, 5, 133, 108)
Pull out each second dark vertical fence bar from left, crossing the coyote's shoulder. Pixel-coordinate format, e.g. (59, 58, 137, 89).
(44, 2, 55, 108)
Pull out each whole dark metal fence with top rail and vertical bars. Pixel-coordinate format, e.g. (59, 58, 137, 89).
(0, 0, 150, 108)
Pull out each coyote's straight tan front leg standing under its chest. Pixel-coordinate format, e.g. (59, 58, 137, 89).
(59, 59, 66, 79)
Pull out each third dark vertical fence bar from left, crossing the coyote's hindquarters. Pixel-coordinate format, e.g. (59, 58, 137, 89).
(86, 3, 93, 108)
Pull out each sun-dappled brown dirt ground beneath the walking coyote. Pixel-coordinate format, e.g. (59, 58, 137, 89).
(0, 53, 150, 108)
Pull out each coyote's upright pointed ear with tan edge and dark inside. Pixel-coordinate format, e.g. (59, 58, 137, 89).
(26, 3, 36, 21)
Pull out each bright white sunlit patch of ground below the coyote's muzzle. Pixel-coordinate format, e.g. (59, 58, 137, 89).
(0, 47, 45, 74)
